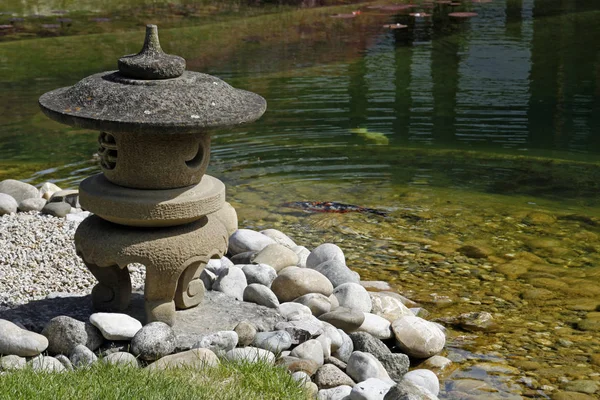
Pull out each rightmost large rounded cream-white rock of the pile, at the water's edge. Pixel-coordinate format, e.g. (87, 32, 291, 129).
(392, 315, 446, 358)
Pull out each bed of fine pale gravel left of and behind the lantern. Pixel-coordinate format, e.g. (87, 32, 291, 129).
(0, 211, 145, 309)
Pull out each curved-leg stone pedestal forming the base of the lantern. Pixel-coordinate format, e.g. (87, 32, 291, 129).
(75, 206, 236, 325)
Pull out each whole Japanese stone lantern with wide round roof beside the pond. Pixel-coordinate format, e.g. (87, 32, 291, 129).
(39, 25, 266, 325)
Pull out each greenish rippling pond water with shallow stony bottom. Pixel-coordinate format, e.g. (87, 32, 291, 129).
(0, 0, 600, 399)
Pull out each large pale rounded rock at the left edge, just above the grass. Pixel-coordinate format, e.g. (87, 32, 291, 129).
(0, 319, 48, 357)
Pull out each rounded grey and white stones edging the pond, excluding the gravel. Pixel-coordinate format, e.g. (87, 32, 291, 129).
(0, 181, 451, 400)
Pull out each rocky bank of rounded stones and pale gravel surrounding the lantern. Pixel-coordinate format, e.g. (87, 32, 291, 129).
(0, 181, 451, 399)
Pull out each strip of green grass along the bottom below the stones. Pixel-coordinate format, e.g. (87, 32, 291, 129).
(0, 361, 308, 400)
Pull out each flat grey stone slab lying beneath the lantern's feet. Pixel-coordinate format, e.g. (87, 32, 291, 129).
(0, 290, 285, 349)
